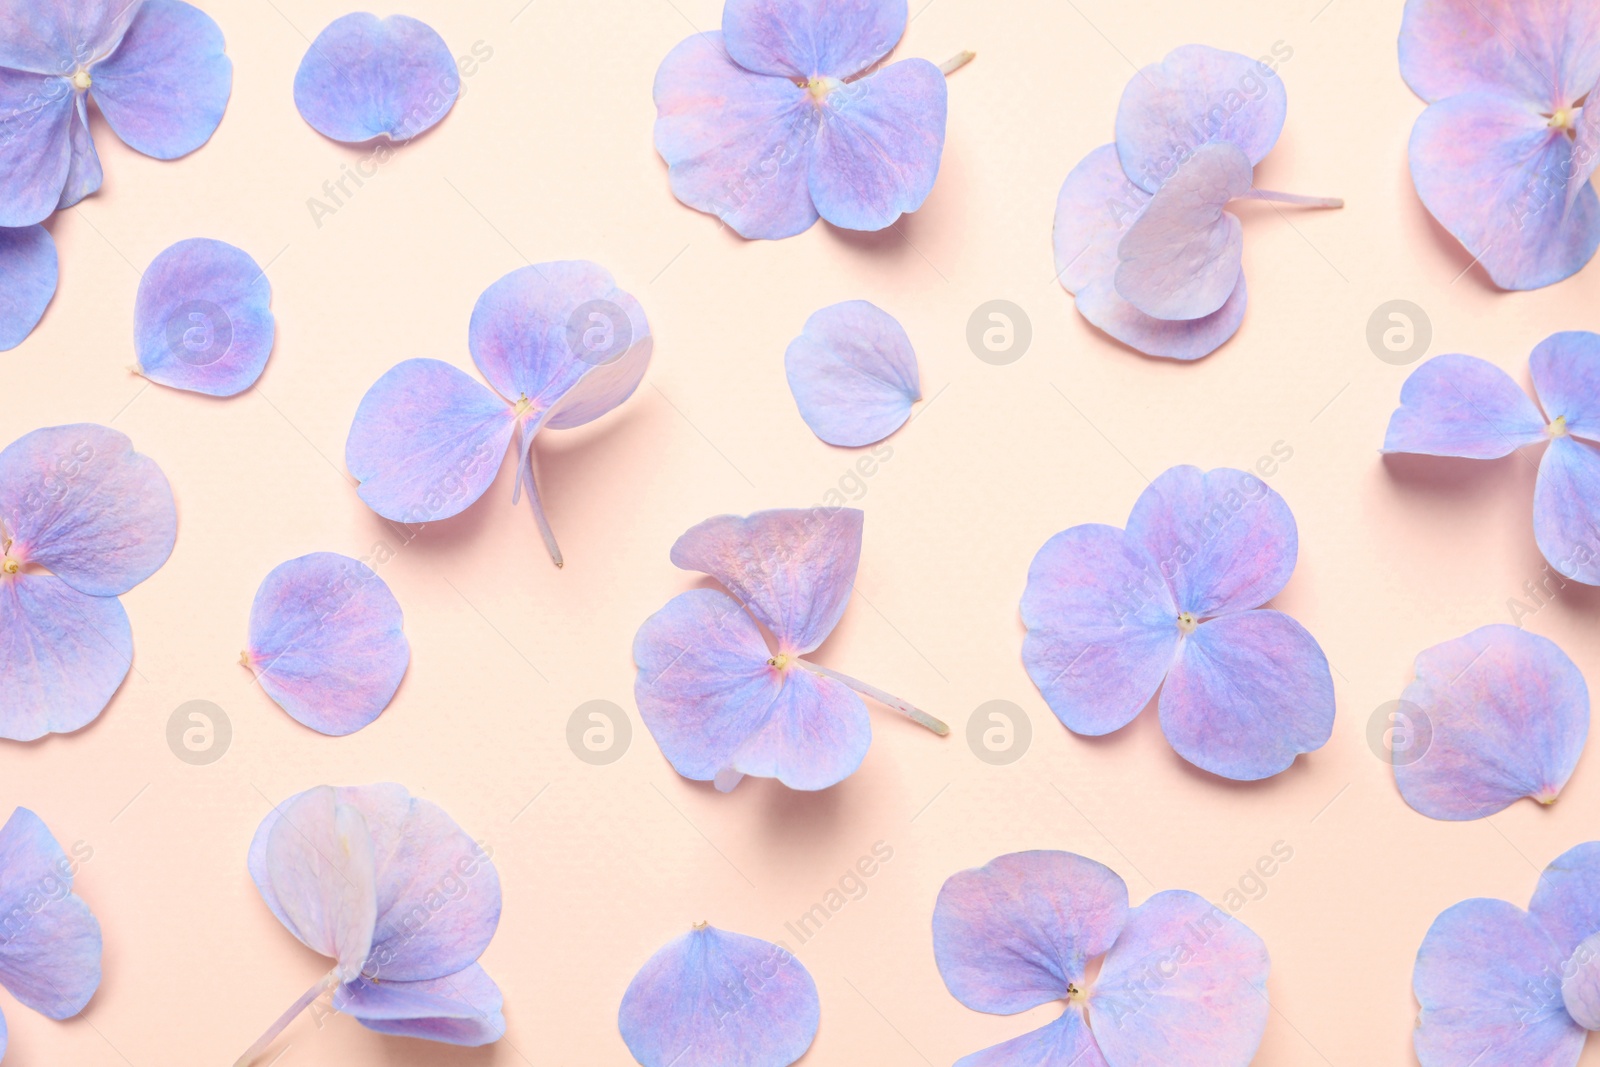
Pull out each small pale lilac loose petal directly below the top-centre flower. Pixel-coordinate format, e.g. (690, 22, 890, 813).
(784, 301, 922, 448)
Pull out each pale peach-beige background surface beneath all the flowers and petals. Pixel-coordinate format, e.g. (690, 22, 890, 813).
(0, 0, 1600, 1067)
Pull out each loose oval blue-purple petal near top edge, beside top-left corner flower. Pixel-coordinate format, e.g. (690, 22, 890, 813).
(294, 11, 461, 144)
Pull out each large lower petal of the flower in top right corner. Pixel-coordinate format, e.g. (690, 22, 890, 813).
(1410, 91, 1600, 290)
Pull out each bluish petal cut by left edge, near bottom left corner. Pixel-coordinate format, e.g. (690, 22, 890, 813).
(0, 808, 101, 1017)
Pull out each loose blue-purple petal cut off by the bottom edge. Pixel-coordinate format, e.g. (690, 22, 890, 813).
(616, 925, 822, 1067)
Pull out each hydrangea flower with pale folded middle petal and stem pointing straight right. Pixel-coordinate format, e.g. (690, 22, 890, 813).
(1054, 45, 1344, 360)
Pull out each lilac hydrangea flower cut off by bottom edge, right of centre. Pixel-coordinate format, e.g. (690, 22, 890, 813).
(933, 851, 1270, 1067)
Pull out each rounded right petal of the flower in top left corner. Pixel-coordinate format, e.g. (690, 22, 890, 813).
(90, 0, 234, 160)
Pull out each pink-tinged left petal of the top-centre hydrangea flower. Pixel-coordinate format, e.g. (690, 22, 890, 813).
(654, 32, 822, 240)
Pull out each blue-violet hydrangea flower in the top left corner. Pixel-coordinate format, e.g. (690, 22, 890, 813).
(0, 0, 234, 227)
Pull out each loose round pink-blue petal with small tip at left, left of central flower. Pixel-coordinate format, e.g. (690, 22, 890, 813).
(250, 552, 411, 737)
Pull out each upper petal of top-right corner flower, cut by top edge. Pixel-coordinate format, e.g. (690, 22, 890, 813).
(1400, 0, 1600, 110)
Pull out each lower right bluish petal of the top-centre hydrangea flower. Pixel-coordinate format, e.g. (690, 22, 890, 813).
(808, 59, 949, 230)
